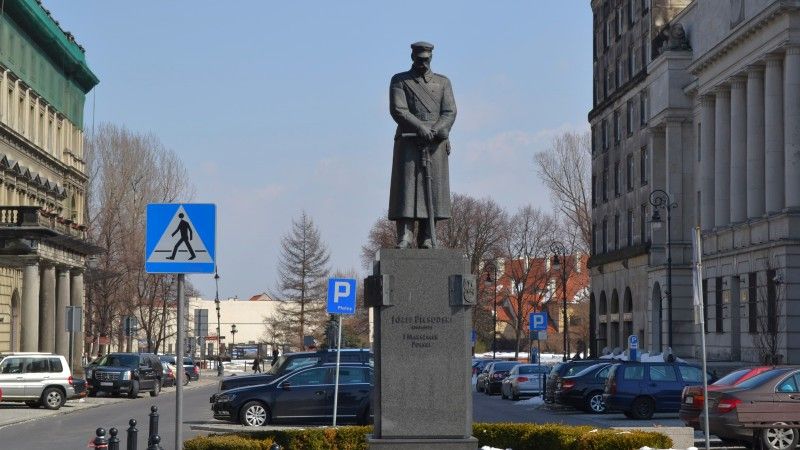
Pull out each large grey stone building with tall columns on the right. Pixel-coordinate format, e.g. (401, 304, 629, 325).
(589, 0, 800, 364)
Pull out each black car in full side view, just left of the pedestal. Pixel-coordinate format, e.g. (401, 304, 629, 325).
(211, 364, 373, 427)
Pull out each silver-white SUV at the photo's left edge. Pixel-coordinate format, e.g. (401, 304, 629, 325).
(0, 353, 78, 409)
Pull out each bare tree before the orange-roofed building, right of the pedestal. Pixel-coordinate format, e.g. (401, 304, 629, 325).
(501, 206, 558, 357)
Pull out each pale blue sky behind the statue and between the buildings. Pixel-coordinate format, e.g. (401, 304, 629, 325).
(44, 0, 592, 298)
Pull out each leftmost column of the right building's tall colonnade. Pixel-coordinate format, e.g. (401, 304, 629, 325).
(700, 95, 714, 230)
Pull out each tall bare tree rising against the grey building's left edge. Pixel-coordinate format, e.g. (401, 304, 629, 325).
(535, 132, 592, 254)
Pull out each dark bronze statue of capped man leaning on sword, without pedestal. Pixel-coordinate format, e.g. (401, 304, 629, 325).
(389, 42, 456, 248)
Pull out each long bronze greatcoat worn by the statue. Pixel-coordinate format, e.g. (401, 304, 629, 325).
(389, 71, 456, 220)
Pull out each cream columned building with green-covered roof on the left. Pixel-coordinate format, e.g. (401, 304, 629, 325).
(0, 0, 98, 366)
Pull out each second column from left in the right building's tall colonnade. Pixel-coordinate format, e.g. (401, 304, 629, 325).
(714, 86, 731, 227)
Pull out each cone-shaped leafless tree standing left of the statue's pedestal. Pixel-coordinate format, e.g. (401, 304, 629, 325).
(275, 212, 330, 348)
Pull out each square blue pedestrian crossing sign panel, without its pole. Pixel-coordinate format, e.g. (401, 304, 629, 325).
(144, 203, 217, 273)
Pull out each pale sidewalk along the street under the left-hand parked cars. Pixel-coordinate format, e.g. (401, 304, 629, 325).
(0, 370, 219, 428)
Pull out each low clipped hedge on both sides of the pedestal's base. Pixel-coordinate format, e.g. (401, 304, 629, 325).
(183, 423, 672, 450)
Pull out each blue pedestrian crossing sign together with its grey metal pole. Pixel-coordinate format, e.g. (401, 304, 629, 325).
(144, 203, 217, 448)
